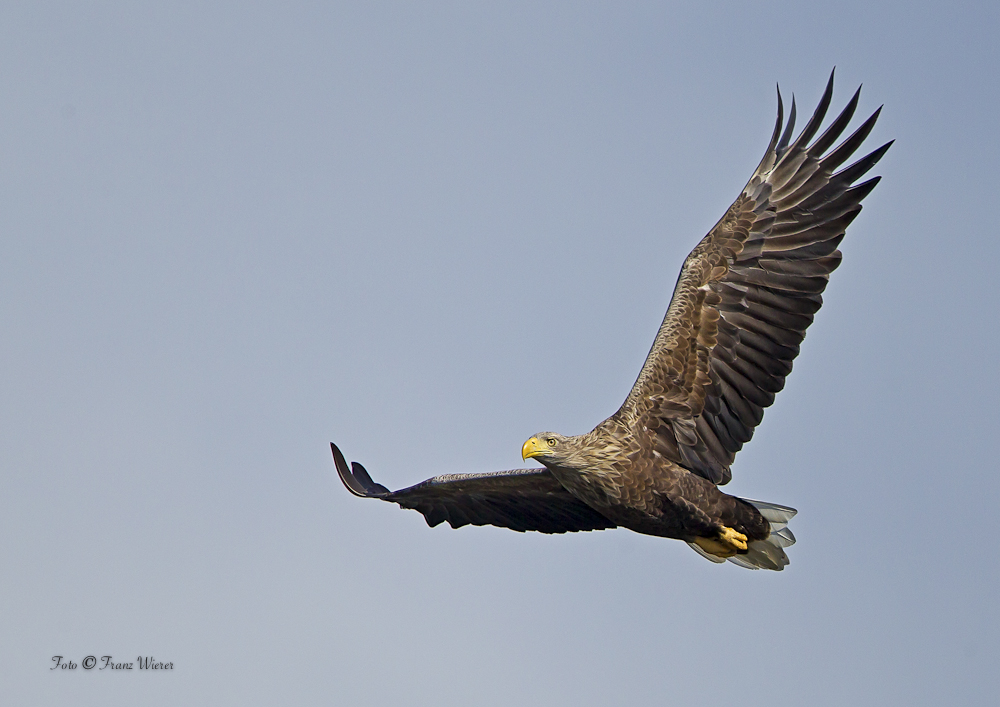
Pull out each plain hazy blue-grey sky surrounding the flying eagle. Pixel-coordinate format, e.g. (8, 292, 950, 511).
(0, 0, 1000, 707)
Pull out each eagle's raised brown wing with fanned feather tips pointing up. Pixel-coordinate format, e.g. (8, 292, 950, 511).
(609, 74, 892, 484)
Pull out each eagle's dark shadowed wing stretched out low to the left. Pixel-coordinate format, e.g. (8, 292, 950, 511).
(330, 443, 615, 533)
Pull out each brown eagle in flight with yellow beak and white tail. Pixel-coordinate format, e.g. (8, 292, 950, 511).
(330, 73, 892, 570)
